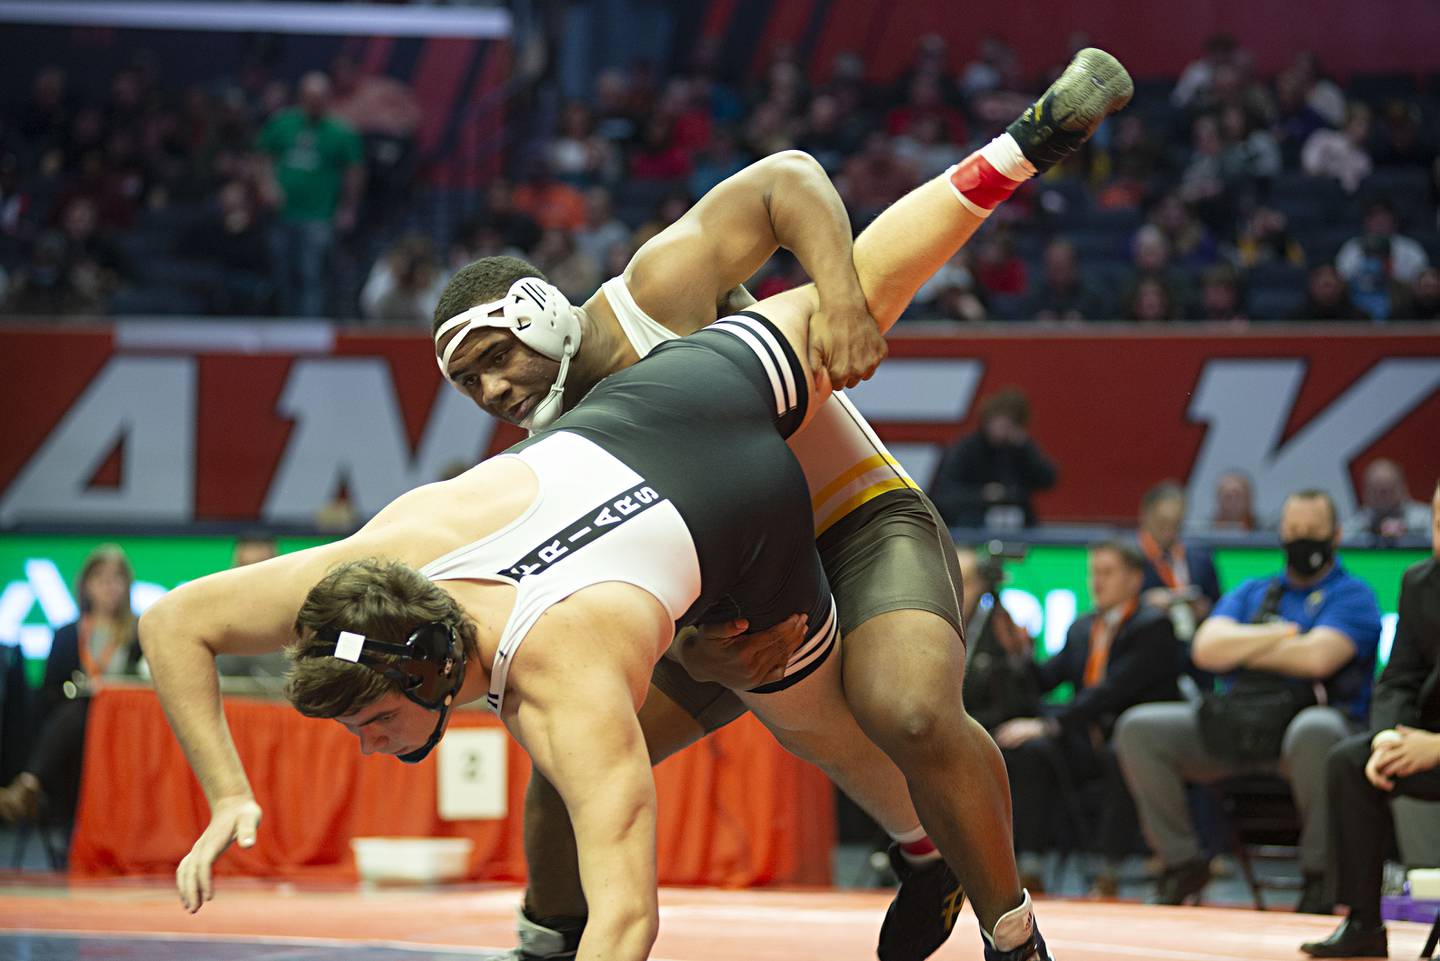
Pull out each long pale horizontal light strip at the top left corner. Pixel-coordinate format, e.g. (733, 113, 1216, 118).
(0, 0, 514, 40)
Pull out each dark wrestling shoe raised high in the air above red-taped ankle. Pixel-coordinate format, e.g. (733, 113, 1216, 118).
(1005, 46, 1135, 173)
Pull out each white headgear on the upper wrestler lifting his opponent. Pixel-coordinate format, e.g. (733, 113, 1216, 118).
(435, 277, 582, 431)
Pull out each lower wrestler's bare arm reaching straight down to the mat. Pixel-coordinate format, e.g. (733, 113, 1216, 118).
(504, 584, 674, 961)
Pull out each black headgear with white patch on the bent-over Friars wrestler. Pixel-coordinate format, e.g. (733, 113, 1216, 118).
(315, 621, 465, 764)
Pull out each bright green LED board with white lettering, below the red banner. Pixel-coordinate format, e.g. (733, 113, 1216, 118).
(0, 535, 1426, 677)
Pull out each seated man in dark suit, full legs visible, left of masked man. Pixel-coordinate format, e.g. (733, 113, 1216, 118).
(995, 542, 1179, 895)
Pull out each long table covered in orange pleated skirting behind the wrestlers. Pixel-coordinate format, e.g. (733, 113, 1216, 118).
(71, 687, 835, 888)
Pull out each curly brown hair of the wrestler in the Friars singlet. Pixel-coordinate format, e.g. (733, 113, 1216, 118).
(285, 558, 477, 718)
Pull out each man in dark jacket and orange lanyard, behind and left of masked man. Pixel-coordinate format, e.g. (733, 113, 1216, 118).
(1138, 481, 1220, 644)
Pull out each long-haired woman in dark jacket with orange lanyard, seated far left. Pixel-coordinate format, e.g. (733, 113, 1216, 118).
(0, 545, 141, 823)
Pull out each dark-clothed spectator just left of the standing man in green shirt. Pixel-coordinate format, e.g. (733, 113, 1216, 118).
(183, 180, 274, 317)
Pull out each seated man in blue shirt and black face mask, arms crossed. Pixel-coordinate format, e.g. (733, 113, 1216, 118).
(1115, 490, 1380, 913)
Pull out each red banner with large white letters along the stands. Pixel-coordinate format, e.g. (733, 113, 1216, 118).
(0, 321, 1440, 527)
